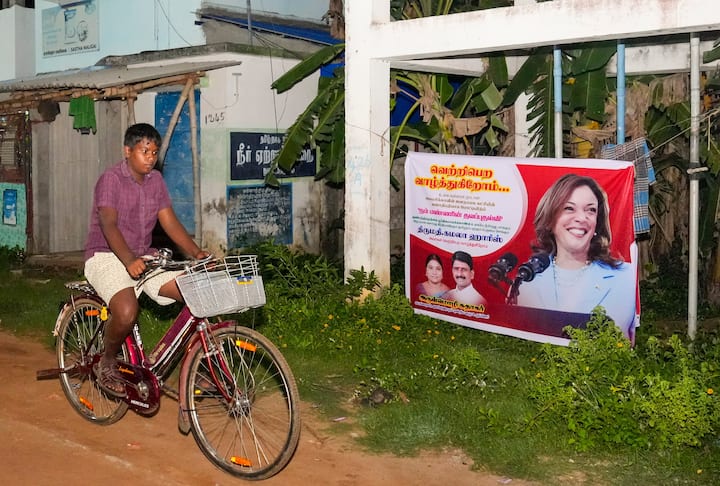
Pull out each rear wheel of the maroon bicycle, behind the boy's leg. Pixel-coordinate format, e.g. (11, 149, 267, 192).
(55, 297, 128, 425)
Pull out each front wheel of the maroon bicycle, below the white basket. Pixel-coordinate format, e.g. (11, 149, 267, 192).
(186, 326, 301, 480)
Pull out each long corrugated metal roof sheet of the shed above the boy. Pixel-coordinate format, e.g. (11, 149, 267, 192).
(0, 61, 238, 92)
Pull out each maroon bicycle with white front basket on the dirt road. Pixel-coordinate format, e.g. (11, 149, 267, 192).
(37, 250, 300, 480)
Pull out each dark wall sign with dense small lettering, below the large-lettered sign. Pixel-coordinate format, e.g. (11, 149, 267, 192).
(227, 184, 292, 248)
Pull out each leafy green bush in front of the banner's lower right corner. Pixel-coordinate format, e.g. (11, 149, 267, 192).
(526, 312, 720, 451)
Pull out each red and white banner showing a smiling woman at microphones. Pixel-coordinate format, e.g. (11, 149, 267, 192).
(405, 152, 639, 344)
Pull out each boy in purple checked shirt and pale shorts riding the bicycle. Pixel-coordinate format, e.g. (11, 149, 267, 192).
(85, 123, 209, 396)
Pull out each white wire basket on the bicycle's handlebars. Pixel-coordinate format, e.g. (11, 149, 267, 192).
(176, 255, 265, 317)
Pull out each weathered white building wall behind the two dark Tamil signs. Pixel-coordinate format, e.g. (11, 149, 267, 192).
(135, 55, 322, 254)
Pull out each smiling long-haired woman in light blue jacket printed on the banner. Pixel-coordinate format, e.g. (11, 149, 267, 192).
(517, 174, 637, 339)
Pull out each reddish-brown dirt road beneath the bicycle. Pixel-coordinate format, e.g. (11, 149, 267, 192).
(0, 332, 530, 486)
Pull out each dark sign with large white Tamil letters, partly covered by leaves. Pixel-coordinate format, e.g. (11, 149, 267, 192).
(230, 132, 316, 181)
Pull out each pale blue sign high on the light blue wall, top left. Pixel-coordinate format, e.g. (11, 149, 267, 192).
(42, 0, 100, 57)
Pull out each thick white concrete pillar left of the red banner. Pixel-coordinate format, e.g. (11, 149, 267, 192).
(344, 0, 390, 285)
